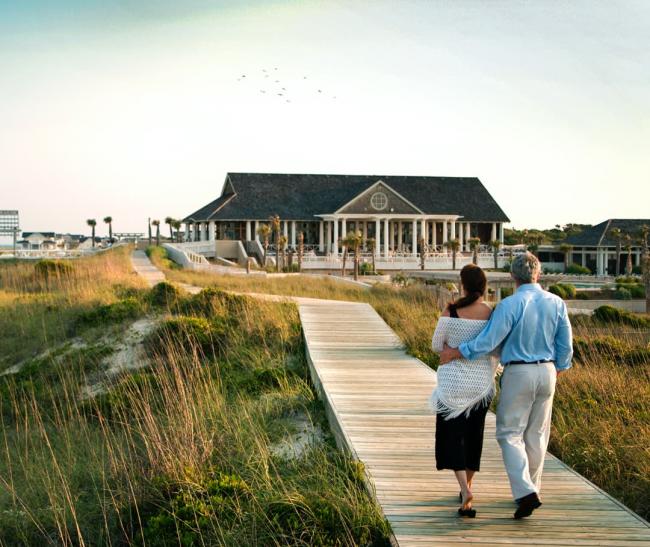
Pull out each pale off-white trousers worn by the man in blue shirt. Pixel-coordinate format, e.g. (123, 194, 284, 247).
(497, 363, 556, 499)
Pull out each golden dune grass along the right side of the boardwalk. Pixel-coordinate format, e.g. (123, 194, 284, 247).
(148, 248, 650, 519)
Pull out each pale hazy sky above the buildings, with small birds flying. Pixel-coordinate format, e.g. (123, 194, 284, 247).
(0, 0, 650, 239)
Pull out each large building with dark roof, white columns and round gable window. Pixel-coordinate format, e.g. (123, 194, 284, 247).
(183, 173, 509, 264)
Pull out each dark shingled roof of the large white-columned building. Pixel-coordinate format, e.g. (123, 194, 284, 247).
(184, 173, 509, 222)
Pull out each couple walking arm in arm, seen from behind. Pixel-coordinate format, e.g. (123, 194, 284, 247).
(431, 253, 573, 519)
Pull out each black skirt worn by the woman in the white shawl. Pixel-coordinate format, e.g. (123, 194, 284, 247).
(436, 402, 490, 471)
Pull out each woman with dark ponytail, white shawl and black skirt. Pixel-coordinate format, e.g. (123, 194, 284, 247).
(431, 264, 498, 518)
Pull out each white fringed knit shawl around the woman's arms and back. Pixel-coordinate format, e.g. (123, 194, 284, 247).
(429, 317, 498, 420)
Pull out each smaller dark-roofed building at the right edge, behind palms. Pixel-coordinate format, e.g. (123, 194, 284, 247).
(566, 218, 650, 275)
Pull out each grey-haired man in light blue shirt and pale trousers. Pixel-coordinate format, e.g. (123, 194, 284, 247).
(440, 253, 573, 519)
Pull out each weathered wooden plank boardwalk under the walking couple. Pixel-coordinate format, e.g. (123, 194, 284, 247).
(298, 301, 650, 547)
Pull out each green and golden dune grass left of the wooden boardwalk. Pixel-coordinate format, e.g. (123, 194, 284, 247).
(0, 253, 388, 546)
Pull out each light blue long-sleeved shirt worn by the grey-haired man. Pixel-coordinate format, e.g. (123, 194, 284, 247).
(458, 283, 573, 370)
